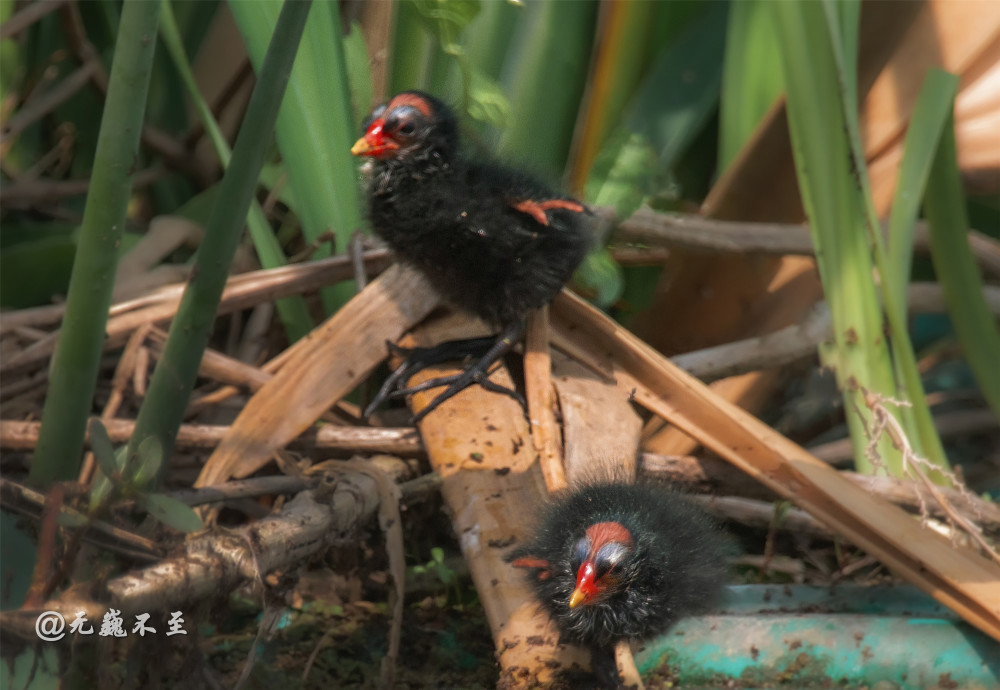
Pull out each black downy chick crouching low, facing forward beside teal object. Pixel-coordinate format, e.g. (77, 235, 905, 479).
(508, 482, 729, 688)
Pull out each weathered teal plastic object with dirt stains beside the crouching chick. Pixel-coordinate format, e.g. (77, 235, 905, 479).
(636, 585, 1000, 690)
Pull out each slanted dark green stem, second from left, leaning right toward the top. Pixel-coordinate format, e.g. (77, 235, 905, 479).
(126, 0, 312, 481)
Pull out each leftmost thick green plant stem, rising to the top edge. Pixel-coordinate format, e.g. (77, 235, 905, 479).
(29, 0, 160, 487)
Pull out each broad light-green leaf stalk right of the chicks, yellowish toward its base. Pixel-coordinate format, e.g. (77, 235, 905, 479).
(771, 2, 902, 476)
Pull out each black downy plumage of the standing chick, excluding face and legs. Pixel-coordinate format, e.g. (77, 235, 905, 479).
(368, 92, 590, 327)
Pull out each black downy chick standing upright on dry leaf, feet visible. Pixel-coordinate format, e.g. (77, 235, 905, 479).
(351, 91, 589, 422)
